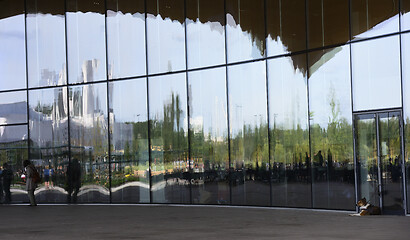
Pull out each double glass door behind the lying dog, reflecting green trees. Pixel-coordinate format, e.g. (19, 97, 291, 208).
(355, 111, 405, 215)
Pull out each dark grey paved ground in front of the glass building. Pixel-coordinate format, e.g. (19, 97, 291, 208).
(0, 205, 410, 240)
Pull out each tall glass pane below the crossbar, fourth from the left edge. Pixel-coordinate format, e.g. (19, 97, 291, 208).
(110, 78, 150, 203)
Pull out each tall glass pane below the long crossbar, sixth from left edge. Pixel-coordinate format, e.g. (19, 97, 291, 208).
(188, 68, 230, 204)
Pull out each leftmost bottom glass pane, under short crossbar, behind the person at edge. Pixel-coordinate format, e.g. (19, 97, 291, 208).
(0, 125, 28, 203)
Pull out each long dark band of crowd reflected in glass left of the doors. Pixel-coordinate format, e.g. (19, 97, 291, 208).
(160, 150, 354, 188)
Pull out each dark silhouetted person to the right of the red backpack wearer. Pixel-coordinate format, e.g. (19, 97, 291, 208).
(67, 159, 81, 203)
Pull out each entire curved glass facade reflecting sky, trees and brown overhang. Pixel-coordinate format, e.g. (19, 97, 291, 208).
(0, 0, 410, 212)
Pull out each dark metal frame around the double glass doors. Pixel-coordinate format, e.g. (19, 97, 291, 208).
(352, 108, 407, 215)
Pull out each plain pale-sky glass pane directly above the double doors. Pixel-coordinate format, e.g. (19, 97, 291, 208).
(352, 36, 401, 111)
